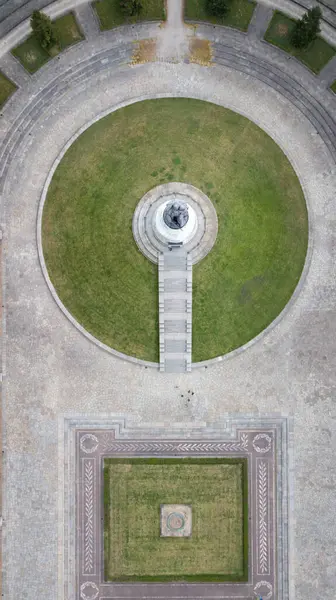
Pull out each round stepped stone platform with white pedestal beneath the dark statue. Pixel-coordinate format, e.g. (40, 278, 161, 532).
(132, 182, 218, 264)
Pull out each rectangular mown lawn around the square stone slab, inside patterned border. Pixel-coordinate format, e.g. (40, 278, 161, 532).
(104, 458, 248, 581)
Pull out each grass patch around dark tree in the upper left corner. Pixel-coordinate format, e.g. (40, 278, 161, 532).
(12, 13, 83, 73)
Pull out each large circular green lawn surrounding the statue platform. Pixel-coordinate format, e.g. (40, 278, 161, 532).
(42, 98, 308, 361)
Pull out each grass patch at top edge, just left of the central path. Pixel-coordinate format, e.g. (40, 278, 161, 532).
(93, 0, 166, 30)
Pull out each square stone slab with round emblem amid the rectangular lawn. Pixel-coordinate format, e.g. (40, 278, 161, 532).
(160, 504, 192, 537)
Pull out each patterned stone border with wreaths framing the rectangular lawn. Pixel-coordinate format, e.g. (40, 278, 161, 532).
(62, 416, 291, 600)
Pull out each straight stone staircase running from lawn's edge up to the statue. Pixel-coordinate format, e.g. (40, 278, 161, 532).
(159, 248, 192, 373)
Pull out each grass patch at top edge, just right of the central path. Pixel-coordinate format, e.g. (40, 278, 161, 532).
(185, 0, 255, 31)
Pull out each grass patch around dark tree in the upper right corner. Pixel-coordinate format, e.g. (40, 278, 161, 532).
(265, 11, 336, 73)
